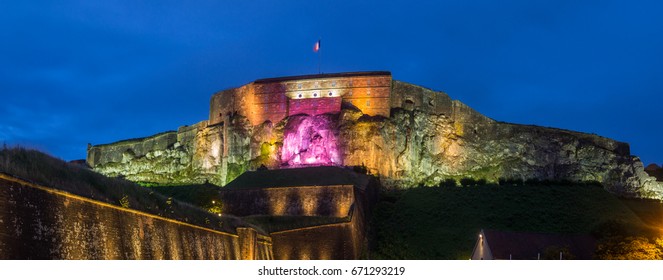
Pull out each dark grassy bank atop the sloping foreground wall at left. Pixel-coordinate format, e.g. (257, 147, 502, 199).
(0, 147, 242, 232)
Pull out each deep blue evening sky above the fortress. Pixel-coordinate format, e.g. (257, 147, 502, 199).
(0, 0, 663, 164)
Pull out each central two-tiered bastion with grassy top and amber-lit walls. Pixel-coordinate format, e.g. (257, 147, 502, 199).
(220, 166, 379, 259)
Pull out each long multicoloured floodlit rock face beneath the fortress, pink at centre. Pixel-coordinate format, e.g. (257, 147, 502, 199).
(88, 81, 663, 199)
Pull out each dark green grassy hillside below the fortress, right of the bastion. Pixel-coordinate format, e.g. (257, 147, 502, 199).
(370, 186, 646, 259)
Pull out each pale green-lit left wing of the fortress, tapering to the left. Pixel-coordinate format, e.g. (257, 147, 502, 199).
(87, 121, 225, 183)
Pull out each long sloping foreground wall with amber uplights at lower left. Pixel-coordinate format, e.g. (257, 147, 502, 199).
(0, 174, 273, 259)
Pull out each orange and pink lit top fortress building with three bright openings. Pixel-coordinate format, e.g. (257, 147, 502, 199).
(209, 72, 392, 125)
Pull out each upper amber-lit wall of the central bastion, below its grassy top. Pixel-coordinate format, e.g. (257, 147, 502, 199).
(220, 185, 355, 217)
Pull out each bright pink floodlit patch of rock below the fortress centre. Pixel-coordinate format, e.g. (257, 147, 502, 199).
(281, 115, 341, 166)
